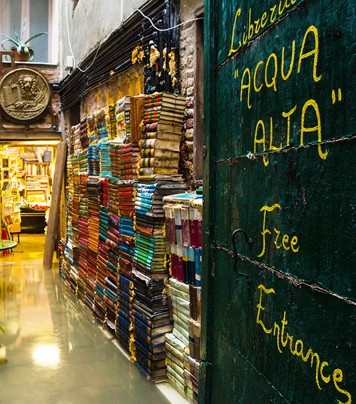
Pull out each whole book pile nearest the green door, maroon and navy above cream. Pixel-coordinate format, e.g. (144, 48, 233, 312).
(163, 192, 203, 402)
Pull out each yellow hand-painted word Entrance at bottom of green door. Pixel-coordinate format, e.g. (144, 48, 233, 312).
(256, 284, 352, 404)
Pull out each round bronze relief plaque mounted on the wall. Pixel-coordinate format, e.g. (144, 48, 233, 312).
(0, 68, 50, 122)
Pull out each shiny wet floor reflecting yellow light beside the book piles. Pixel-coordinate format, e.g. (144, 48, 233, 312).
(0, 234, 186, 404)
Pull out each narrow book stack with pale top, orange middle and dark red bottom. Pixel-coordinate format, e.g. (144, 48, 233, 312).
(85, 176, 100, 308)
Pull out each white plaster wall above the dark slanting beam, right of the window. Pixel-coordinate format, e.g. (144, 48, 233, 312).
(59, 0, 146, 78)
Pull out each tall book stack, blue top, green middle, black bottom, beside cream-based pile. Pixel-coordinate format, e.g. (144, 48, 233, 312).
(132, 182, 186, 382)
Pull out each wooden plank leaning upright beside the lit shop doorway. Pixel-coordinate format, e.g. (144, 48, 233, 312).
(43, 142, 67, 269)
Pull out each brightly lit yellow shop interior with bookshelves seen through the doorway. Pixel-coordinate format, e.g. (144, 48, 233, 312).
(0, 141, 58, 248)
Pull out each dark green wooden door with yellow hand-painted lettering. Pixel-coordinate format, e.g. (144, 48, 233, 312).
(200, 0, 356, 403)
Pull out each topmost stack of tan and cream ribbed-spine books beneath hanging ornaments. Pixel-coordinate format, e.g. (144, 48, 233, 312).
(139, 93, 186, 179)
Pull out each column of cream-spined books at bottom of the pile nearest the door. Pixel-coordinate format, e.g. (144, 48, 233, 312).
(166, 278, 193, 397)
